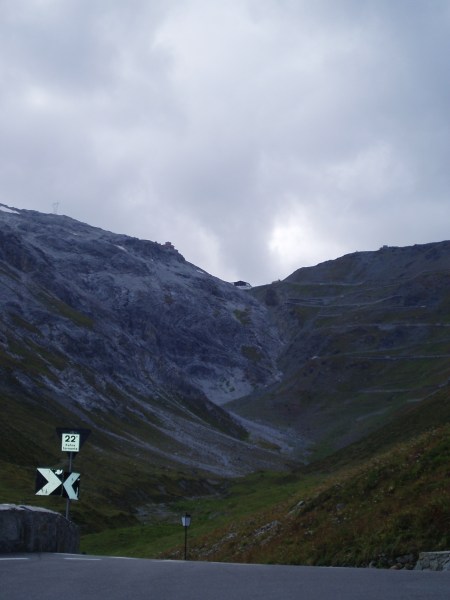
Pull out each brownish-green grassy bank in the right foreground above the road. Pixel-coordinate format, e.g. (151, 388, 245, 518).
(181, 426, 450, 567)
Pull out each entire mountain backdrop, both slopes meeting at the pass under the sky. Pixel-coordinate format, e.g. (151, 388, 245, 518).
(0, 205, 450, 529)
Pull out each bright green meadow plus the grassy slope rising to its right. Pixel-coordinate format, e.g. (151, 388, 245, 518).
(83, 390, 450, 567)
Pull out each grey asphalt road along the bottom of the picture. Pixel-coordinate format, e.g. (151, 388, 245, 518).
(0, 554, 450, 600)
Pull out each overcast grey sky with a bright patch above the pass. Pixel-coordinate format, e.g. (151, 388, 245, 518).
(0, 0, 450, 285)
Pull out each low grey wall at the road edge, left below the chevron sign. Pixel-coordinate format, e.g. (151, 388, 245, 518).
(0, 504, 80, 554)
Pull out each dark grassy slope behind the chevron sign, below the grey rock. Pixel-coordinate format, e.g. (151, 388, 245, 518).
(0, 384, 229, 532)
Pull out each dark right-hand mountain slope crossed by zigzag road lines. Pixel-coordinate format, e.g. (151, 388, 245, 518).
(236, 242, 450, 453)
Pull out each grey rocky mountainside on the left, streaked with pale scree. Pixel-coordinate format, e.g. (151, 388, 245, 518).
(0, 206, 292, 475)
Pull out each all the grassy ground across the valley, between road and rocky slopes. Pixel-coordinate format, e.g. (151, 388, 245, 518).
(0, 376, 450, 566)
